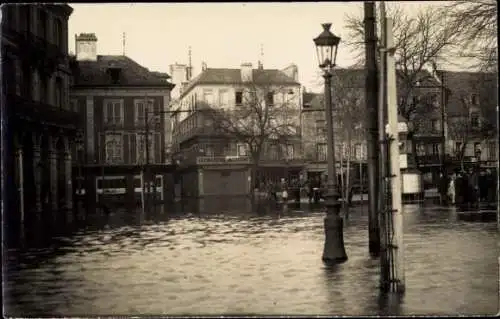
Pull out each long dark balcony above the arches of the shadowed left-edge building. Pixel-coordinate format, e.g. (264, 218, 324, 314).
(7, 94, 83, 130)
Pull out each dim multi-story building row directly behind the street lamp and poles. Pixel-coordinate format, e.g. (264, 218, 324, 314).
(302, 69, 442, 186)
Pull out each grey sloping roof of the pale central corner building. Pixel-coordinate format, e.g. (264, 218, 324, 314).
(182, 68, 300, 99)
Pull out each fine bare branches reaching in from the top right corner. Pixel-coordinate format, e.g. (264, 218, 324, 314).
(442, 0, 498, 71)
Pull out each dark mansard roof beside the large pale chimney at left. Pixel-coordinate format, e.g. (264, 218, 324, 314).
(72, 55, 174, 89)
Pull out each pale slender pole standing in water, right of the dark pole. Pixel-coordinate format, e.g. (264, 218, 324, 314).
(382, 18, 405, 292)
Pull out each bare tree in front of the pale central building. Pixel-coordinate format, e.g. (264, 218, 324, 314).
(204, 83, 300, 201)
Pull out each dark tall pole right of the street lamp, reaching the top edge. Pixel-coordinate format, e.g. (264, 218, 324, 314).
(360, 1, 380, 256)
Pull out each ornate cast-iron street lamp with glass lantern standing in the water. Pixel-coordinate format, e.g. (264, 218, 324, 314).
(314, 23, 347, 263)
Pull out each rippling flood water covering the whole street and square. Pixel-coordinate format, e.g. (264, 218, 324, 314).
(4, 206, 499, 317)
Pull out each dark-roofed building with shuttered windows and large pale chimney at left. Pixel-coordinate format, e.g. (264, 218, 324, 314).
(71, 33, 174, 208)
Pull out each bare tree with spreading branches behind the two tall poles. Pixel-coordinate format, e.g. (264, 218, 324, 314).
(346, 4, 456, 124)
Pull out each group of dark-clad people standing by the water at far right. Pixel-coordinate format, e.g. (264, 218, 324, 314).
(439, 169, 497, 206)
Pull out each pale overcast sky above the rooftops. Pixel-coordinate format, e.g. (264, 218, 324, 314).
(69, 1, 454, 90)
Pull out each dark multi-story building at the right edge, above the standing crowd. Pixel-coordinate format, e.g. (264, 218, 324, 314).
(438, 71, 498, 171)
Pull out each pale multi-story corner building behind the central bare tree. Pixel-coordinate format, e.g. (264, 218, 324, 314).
(173, 63, 302, 197)
